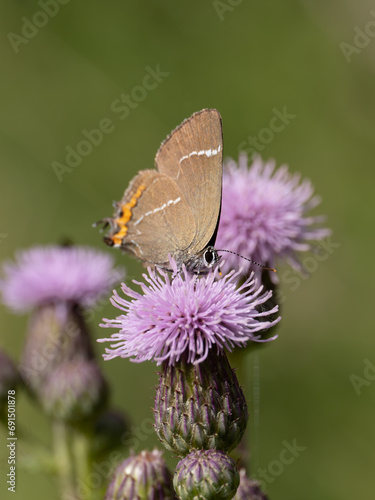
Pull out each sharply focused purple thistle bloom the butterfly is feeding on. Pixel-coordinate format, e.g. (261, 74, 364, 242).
(98, 261, 280, 365)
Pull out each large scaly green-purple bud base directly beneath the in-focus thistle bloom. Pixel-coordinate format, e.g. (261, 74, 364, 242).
(154, 349, 248, 456)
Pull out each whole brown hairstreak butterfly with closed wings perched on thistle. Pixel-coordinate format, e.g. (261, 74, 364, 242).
(100, 109, 223, 273)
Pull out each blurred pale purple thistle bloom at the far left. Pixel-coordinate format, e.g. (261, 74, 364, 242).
(0, 246, 123, 313)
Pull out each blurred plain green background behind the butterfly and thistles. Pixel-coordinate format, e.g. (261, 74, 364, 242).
(0, 0, 375, 500)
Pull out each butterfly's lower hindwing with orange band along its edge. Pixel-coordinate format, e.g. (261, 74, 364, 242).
(107, 170, 196, 267)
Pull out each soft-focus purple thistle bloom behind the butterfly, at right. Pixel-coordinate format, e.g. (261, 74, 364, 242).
(216, 153, 330, 280)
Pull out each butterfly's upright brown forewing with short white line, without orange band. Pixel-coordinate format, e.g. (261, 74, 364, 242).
(155, 109, 223, 255)
